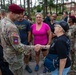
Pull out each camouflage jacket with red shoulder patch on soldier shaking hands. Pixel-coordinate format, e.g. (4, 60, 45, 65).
(1, 17, 33, 69)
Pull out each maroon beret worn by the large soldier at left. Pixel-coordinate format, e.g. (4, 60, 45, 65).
(8, 4, 24, 14)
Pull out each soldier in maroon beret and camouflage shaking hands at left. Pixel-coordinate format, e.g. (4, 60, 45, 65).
(1, 4, 34, 75)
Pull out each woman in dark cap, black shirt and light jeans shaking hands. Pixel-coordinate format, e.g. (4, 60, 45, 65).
(35, 21, 71, 75)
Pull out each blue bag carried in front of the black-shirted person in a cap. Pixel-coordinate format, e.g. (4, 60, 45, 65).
(44, 54, 59, 71)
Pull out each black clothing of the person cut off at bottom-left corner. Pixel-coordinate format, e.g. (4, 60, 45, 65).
(0, 45, 14, 75)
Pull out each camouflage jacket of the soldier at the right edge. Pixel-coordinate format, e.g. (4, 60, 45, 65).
(67, 25, 76, 49)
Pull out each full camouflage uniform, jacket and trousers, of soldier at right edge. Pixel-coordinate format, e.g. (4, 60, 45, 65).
(67, 25, 76, 69)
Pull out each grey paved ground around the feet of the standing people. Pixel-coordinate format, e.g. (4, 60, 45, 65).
(24, 61, 76, 75)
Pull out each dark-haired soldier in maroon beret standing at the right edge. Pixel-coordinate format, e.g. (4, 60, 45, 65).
(67, 16, 76, 69)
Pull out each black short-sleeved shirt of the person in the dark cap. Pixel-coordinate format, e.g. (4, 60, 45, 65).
(49, 35, 71, 68)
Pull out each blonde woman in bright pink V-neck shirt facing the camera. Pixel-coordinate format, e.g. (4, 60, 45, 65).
(31, 13, 52, 72)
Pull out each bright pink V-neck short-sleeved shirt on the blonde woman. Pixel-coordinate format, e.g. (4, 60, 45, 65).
(31, 23, 50, 45)
